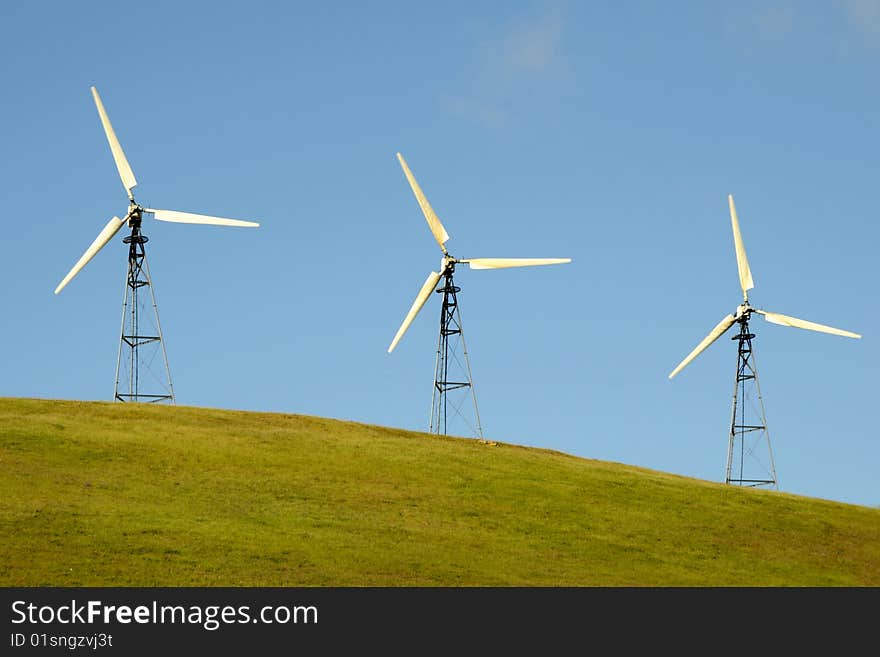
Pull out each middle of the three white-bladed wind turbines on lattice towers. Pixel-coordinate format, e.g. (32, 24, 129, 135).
(388, 153, 571, 440)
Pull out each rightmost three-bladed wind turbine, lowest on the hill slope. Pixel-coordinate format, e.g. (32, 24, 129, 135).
(669, 195, 862, 487)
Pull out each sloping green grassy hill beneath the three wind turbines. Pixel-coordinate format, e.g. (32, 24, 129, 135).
(0, 399, 880, 586)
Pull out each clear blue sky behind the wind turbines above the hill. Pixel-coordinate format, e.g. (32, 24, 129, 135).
(0, 0, 880, 506)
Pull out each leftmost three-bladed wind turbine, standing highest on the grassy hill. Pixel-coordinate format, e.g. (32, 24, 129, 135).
(55, 87, 259, 404)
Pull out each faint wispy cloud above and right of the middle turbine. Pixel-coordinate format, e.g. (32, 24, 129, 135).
(441, 8, 568, 128)
